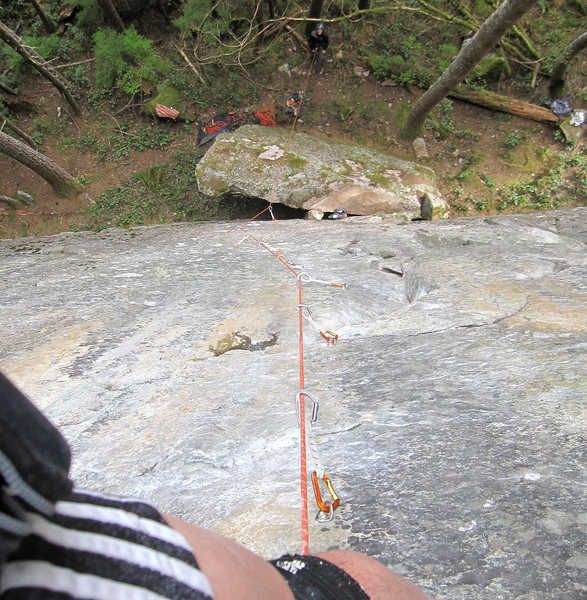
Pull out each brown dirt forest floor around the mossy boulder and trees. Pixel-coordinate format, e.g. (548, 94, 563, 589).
(0, 58, 580, 238)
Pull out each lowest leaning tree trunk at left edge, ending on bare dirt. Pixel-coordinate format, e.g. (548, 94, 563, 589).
(0, 131, 83, 198)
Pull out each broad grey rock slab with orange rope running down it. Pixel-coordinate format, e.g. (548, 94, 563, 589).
(0, 209, 587, 600)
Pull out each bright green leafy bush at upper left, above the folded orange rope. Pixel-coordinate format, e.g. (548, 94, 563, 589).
(94, 27, 169, 95)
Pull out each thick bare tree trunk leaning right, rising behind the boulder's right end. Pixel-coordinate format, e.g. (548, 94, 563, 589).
(402, 0, 538, 139)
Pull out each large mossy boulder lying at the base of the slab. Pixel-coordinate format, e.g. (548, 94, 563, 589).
(196, 125, 440, 220)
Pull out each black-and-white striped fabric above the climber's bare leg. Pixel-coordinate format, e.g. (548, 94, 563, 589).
(0, 492, 212, 600)
